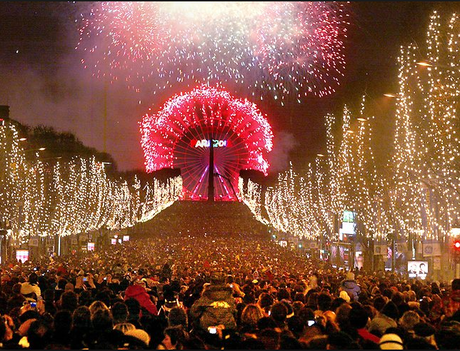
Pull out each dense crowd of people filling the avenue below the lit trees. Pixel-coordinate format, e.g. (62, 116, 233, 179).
(0, 227, 460, 350)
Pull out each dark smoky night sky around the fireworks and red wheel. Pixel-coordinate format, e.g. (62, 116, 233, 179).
(0, 1, 460, 173)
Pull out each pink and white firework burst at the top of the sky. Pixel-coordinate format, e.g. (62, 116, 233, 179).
(77, 2, 348, 103)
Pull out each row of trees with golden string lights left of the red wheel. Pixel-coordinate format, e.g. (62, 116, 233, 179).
(0, 122, 182, 242)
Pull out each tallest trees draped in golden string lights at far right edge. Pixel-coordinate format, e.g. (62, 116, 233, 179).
(390, 12, 460, 248)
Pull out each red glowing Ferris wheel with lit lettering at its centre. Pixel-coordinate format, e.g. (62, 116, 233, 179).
(140, 86, 273, 201)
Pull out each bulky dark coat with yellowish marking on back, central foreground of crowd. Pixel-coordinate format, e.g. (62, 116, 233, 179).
(190, 285, 236, 331)
